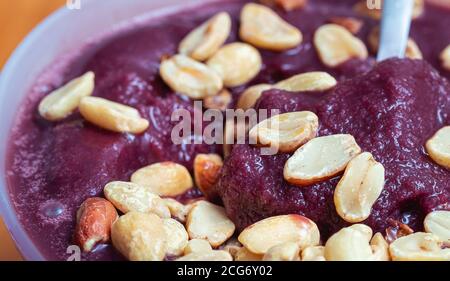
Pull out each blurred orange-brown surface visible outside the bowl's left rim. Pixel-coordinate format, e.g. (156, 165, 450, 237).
(0, 0, 66, 261)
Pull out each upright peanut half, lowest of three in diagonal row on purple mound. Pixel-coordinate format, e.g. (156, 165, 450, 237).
(334, 152, 384, 223)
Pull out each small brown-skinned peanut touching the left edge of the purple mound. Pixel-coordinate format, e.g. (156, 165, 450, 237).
(194, 154, 223, 200)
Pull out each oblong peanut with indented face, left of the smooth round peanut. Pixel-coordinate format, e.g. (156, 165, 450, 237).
(159, 55, 223, 99)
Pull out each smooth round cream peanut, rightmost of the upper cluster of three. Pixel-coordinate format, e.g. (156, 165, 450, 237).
(207, 43, 262, 87)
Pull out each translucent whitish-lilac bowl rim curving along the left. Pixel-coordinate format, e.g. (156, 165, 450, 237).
(0, 0, 217, 260)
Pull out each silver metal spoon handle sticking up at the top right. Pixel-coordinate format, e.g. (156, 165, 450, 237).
(377, 0, 414, 61)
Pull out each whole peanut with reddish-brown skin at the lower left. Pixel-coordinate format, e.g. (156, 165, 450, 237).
(74, 197, 118, 252)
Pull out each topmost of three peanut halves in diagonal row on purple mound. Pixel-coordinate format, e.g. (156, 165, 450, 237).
(249, 111, 319, 153)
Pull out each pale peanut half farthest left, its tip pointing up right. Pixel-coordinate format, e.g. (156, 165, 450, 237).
(38, 71, 95, 121)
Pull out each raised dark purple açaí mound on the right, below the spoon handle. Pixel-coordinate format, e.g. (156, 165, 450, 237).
(216, 59, 450, 237)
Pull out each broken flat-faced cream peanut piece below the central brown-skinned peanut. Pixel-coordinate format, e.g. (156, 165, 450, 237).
(186, 201, 235, 247)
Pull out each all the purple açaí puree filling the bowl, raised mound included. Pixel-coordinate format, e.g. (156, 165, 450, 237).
(7, 0, 450, 260)
